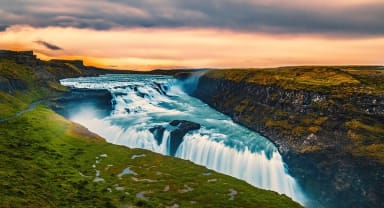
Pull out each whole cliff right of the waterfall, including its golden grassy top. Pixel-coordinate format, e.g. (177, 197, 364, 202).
(193, 67, 384, 207)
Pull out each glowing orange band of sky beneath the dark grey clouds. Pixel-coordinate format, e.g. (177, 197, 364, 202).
(0, 26, 384, 70)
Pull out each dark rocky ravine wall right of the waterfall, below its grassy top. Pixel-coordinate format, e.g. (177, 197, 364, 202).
(193, 72, 384, 207)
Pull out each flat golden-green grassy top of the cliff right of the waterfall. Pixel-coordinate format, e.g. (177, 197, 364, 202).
(206, 66, 384, 93)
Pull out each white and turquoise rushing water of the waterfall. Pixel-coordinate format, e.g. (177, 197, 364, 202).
(61, 75, 305, 204)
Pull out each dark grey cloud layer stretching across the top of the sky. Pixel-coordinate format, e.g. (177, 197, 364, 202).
(0, 0, 384, 36)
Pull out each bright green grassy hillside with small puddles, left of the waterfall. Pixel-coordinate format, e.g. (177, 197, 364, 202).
(0, 54, 300, 208)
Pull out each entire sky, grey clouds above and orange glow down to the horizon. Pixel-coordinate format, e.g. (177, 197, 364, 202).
(0, 0, 384, 70)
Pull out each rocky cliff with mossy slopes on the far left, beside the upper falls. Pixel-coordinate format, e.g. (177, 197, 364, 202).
(0, 50, 118, 117)
